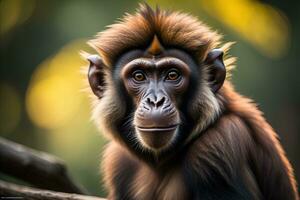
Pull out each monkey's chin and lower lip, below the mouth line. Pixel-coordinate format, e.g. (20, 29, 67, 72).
(136, 125, 178, 151)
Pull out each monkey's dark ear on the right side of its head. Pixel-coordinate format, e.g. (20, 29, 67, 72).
(204, 49, 226, 93)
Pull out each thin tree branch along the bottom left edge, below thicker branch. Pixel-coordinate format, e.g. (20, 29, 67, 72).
(0, 180, 105, 200)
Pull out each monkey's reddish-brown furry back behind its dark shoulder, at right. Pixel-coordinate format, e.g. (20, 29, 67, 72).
(221, 83, 299, 199)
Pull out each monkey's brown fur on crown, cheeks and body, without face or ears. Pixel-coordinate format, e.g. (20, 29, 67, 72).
(90, 5, 298, 199)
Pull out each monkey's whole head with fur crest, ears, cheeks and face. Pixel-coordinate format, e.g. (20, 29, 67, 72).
(88, 5, 232, 158)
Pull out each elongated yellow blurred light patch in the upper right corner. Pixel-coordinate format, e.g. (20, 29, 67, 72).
(200, 0, 290, 58)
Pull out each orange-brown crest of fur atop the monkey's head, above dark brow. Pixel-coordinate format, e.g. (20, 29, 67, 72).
(89, 4, 220, 66)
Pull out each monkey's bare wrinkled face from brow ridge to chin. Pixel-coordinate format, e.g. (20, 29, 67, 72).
(120, 50, 191, 150)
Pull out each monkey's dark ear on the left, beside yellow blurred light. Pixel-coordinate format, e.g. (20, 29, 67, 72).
(87, 55, 105, 99)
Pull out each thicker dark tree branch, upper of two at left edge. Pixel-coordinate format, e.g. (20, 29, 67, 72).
(0, 138, 87, 194)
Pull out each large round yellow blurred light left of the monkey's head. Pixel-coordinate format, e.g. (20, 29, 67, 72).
(26, 40, 92, 129)
